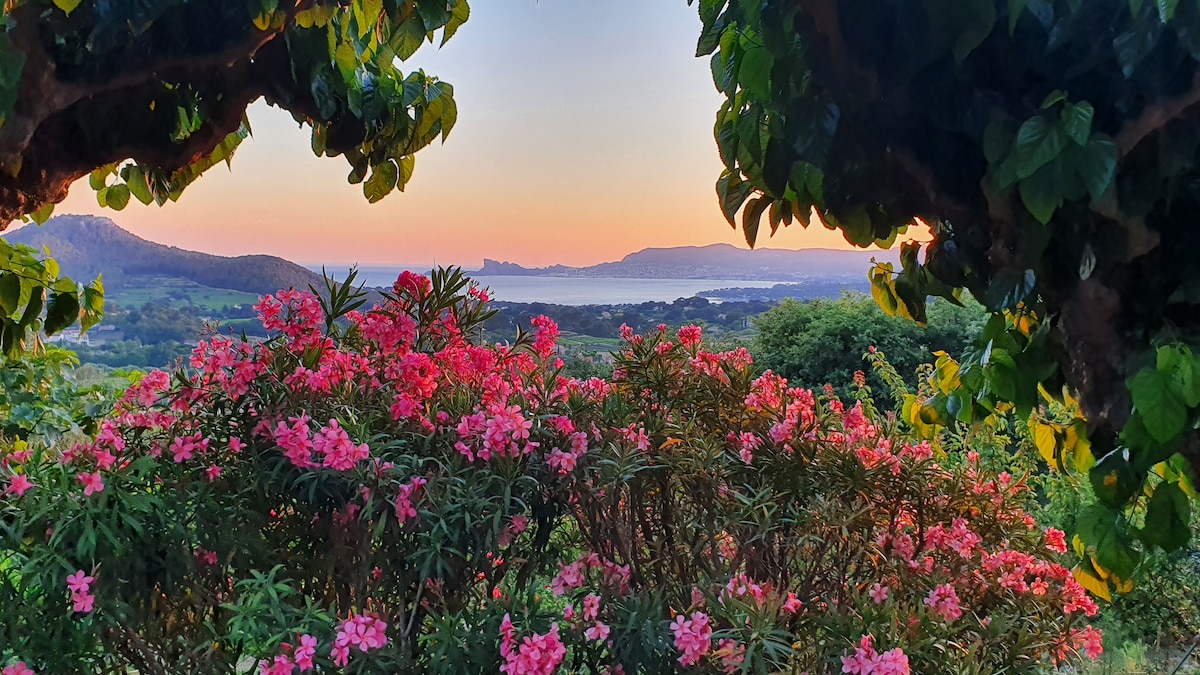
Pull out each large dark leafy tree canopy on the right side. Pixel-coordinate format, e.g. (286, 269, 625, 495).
(696, 0, 1200, 583)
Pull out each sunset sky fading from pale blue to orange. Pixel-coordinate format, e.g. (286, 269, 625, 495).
(55, 0, 873, 267)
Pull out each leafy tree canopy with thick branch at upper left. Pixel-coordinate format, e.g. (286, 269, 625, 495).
(0, 0, 470, 356)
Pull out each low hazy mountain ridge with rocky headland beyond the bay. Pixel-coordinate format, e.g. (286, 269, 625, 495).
(475, 244, 899, 281)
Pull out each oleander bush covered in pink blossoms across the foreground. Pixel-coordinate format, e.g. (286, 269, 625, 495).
(0, 270, 1100, 675)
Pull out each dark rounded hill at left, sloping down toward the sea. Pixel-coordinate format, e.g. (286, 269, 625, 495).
(4, 215, 322, 294)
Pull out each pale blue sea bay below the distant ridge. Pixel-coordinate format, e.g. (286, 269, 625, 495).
(314, 265, 794, 305)
